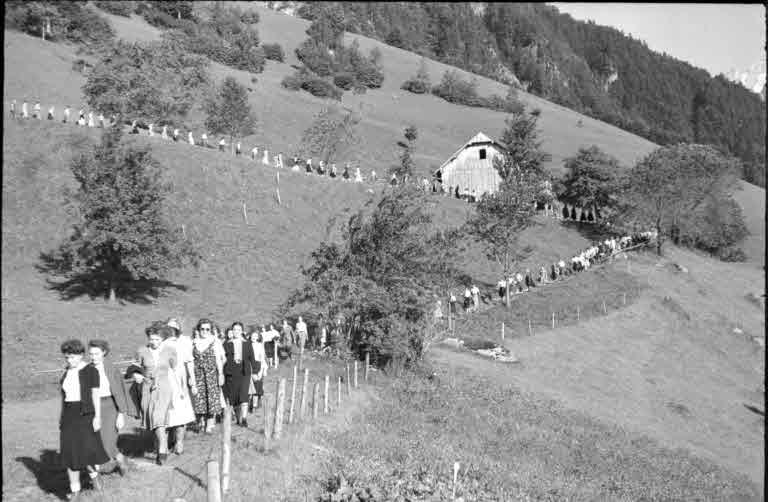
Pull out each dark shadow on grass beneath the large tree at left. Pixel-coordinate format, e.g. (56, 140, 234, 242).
(35, 251, 187, 305)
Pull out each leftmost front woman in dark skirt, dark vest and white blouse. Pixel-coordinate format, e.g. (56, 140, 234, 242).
(59, 340, 109, 500)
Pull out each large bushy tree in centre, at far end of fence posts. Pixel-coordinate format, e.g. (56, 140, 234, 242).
(284, 187, 458, 363)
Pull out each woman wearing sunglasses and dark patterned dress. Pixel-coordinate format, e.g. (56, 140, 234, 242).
(192, 319, 224, 434)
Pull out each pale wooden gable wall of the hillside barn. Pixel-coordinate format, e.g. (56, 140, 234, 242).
(443, 145, 502, 196)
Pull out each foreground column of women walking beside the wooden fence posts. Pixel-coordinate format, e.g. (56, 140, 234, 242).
(60, 317, 316, 499)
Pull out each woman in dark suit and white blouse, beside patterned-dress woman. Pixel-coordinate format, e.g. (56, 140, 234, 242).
(224, 322, 258, 427)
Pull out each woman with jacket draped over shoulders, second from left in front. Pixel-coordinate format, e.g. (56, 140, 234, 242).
(88, 340, 128, 476)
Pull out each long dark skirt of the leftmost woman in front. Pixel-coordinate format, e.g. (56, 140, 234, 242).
(59, 401, 109, 471)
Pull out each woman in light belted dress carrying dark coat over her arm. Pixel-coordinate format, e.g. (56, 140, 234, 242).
(133, 322, 180, 465)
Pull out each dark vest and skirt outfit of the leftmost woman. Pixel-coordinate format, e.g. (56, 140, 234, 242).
(59, 364, 109, 471)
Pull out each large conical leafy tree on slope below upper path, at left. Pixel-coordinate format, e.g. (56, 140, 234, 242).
(42, 125, 199, 302)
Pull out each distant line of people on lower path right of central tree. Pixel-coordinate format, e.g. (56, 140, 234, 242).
(435, 230, 658, 318)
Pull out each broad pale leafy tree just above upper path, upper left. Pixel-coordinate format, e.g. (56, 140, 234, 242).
(83, 40, 208, 123)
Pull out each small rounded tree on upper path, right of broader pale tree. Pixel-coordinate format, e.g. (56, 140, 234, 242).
(205, 77, 256, 150)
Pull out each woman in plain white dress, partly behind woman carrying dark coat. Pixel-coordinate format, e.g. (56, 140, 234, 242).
(165, 319, 197, 455)
